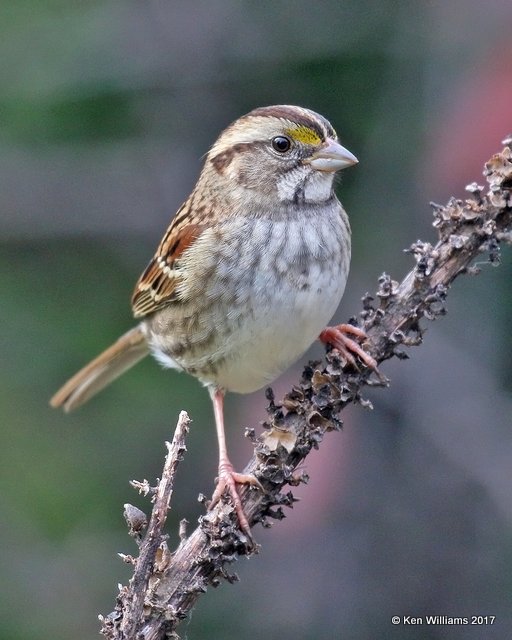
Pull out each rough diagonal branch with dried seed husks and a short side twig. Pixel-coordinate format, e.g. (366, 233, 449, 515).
(101, 137, 512, 640)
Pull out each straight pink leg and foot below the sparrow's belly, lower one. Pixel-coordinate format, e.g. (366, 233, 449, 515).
(209, 387, 263, 536)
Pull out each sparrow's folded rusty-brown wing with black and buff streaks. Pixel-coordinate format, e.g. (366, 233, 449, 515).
(132, 203, 204, 318)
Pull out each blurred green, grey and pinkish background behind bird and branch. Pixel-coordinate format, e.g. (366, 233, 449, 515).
(0, 0, 512, 640)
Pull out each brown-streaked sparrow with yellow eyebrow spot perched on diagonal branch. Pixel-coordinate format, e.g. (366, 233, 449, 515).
(50, 105, 375, 532)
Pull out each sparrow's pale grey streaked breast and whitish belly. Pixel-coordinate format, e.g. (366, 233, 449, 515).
(145, 203, 350, 393)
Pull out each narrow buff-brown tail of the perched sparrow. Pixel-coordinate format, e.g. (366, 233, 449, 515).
(50, 326, 149, 412)
